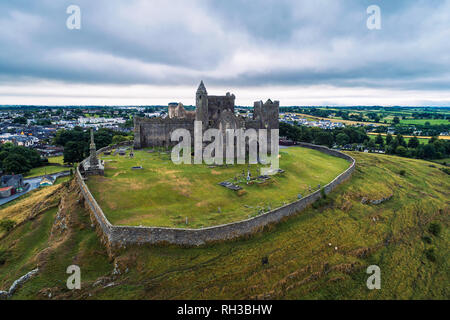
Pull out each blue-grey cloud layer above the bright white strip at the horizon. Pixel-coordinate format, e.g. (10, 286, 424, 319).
(0, 0, 450, 90)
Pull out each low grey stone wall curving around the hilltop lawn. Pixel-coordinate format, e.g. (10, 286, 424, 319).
(76, 143, 356, 248)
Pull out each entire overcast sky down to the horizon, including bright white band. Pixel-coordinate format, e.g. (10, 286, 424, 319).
(0, 0, 450, 106)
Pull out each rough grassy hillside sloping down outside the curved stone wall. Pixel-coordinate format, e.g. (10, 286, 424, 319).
(0, 153, 450, 299)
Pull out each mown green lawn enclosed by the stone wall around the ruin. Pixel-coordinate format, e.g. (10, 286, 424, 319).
(87, 148, 349, 228)
